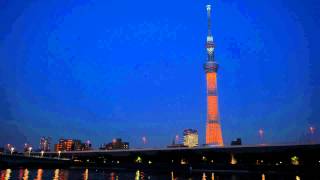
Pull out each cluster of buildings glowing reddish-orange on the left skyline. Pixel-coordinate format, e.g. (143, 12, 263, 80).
(54, 139, 91, 152)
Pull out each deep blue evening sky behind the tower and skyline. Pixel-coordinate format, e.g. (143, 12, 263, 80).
(0, 0, 320, 147)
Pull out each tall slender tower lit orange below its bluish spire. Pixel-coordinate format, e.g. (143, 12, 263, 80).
(204, 5, 223, 146)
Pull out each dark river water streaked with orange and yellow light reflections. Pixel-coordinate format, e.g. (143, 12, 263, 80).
(0, 168, 320, 180)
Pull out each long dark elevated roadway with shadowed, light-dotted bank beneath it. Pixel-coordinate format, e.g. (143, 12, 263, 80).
(0, 144, 320, 172)
